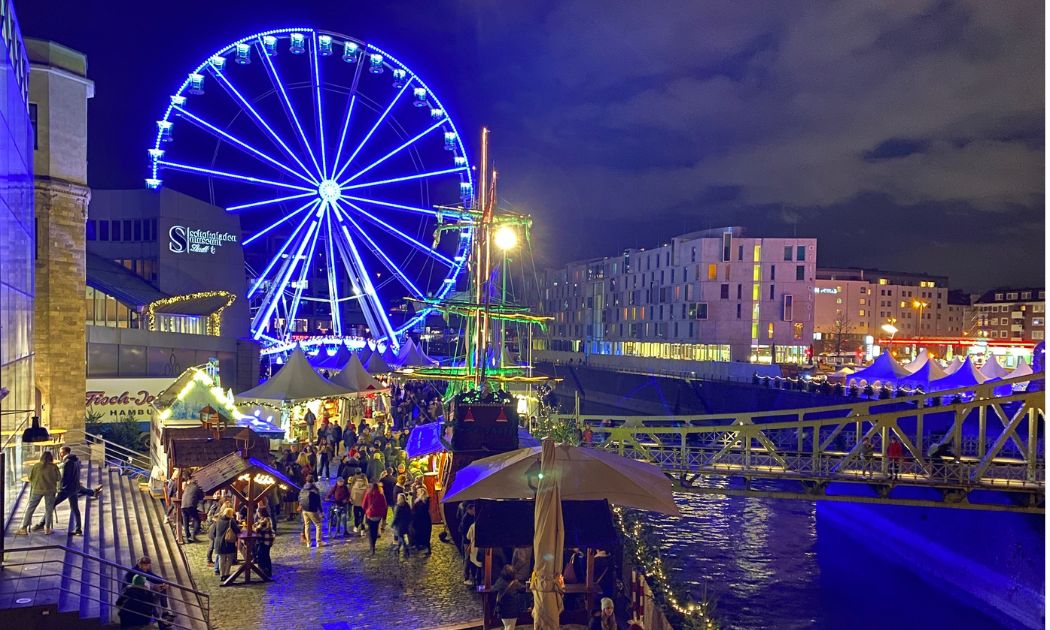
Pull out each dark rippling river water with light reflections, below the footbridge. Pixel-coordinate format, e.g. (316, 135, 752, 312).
(650, 494, 1029, 630)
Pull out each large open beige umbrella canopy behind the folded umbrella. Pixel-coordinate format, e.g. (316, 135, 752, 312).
(444, 444, 680, 516)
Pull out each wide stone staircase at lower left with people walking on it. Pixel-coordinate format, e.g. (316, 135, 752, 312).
(0, 443, 210, 630)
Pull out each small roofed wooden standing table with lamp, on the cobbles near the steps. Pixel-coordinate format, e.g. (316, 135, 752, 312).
(185, 452, 299, 586)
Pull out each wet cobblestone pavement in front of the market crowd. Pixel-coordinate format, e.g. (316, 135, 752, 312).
(178, 521, 481, 630)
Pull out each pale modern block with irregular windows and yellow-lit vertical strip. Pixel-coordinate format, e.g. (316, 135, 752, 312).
(538, 228, 817, 363)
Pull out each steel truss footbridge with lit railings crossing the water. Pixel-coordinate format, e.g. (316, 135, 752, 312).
(557, 373, 1046, 513)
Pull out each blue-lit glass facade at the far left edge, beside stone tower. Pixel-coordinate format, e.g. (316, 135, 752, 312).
(0, 0, 33, 429)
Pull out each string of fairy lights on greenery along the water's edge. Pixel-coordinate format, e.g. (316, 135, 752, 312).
(612, 507, 720, 630)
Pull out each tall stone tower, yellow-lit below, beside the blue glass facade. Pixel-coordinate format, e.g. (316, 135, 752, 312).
(26, 39, 95, 427)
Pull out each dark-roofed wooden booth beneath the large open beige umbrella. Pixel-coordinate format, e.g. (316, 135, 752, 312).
(475, 499, 622, 628)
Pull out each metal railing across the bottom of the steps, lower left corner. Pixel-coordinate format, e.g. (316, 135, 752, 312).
(3, 545, 211, 630)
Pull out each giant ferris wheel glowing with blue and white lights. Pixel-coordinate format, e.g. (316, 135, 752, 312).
(146, 27, 474, 347)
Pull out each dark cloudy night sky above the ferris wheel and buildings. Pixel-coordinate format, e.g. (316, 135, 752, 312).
(15, 0, 1046, 291)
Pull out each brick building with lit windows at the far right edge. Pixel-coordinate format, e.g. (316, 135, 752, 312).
(974, 287, 1046, 342)
